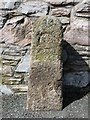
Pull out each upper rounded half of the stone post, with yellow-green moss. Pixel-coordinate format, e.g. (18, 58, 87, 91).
(32, 16, 62, 62)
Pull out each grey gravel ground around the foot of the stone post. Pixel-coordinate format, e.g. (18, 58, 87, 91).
(2, 93, 90, 118)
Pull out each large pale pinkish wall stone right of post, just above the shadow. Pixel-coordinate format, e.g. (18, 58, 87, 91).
(64, 14, 90, 45)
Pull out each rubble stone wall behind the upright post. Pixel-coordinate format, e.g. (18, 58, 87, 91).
(0, 0, 90, 92)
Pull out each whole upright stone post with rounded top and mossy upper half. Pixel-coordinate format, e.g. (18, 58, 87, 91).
(28, 16, 62, 110)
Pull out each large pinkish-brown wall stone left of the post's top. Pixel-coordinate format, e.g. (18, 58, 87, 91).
(0, 16, 32, 46)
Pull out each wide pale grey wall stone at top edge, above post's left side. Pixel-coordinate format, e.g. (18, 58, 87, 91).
(18, 1, 48, 16)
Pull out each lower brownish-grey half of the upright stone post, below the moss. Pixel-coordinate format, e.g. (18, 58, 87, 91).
(28, 62, 62, 111)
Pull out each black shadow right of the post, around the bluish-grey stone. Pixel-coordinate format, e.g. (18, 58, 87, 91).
(62, 41, 90, 109)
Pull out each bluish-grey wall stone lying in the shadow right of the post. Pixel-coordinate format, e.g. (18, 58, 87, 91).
(63, 71, 90, 87)
